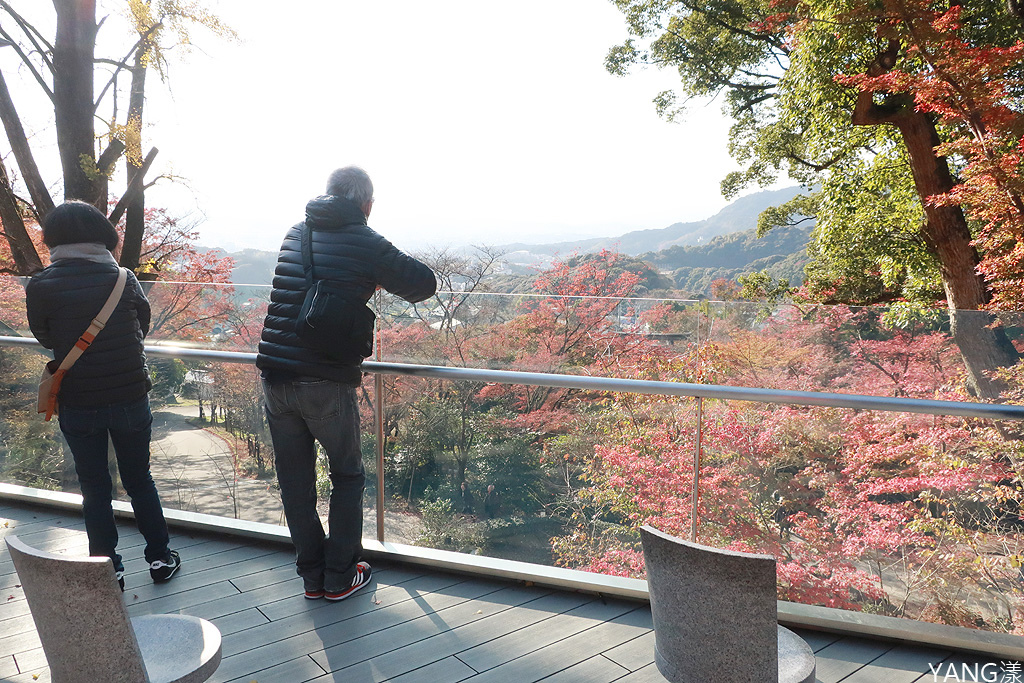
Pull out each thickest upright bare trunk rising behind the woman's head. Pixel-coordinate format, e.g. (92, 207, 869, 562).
(53, 0, 98, 205)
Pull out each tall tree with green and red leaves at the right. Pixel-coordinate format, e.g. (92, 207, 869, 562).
(607, 0, 1024, 399)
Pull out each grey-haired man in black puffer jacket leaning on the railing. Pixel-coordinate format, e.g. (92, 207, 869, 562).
(256, 166, 437, 600)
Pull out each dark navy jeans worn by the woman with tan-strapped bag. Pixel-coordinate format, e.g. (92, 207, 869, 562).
(58, 396, 168, 570)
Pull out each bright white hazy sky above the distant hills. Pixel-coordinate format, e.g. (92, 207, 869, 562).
(4, 0, 757, 250)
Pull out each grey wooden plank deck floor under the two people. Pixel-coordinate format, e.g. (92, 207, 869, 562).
(0, 502, 1003, 683)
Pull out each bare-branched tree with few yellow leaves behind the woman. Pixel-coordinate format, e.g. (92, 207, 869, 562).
(0, 0, 234, 274)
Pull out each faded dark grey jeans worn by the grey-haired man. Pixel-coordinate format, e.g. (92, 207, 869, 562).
(263, 377, 366, 592)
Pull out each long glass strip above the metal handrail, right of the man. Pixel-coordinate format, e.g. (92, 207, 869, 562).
(380, 293, 1024, 400)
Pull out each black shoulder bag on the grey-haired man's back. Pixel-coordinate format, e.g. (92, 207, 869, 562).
(295, 225, 377, 365)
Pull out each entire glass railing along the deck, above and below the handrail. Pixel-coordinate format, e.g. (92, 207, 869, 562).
(0, 281, 1024, 631)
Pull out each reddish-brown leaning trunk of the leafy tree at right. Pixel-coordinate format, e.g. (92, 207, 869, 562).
(853, 49, 1020, 400)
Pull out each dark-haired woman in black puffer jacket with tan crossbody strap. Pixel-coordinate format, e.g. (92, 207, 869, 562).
(26, 202, 180, 589)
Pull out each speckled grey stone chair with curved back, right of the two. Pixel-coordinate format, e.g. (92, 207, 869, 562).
(640, 526, 815, 683)
